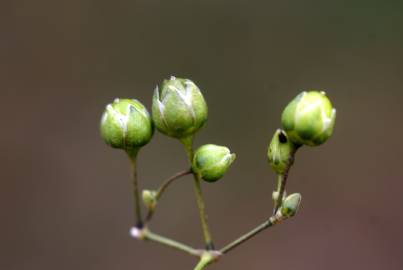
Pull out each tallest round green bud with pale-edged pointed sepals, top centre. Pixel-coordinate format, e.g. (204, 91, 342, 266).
(152, 77, 207, 139)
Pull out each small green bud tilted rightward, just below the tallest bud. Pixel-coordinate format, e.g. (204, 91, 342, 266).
(192, 144, 236, 182)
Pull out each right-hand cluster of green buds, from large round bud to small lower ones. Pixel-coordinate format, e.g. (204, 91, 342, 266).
(267, 91, 336, 216)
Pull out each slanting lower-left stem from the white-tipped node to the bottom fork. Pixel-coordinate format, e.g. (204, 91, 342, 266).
(138, 229, 203, 257)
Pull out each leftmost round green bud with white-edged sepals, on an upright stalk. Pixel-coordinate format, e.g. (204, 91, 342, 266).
(100, 98, 154, 150)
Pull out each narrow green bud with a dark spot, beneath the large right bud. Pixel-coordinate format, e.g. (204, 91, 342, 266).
(267, 129, 296, 174)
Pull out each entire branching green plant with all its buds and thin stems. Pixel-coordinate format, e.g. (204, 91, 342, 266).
(101, 81, 336, 270)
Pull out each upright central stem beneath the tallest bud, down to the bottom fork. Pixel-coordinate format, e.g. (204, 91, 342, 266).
(180, 136, 214, 250)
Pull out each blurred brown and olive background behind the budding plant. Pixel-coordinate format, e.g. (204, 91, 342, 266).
(0, 0, 403, 270)
